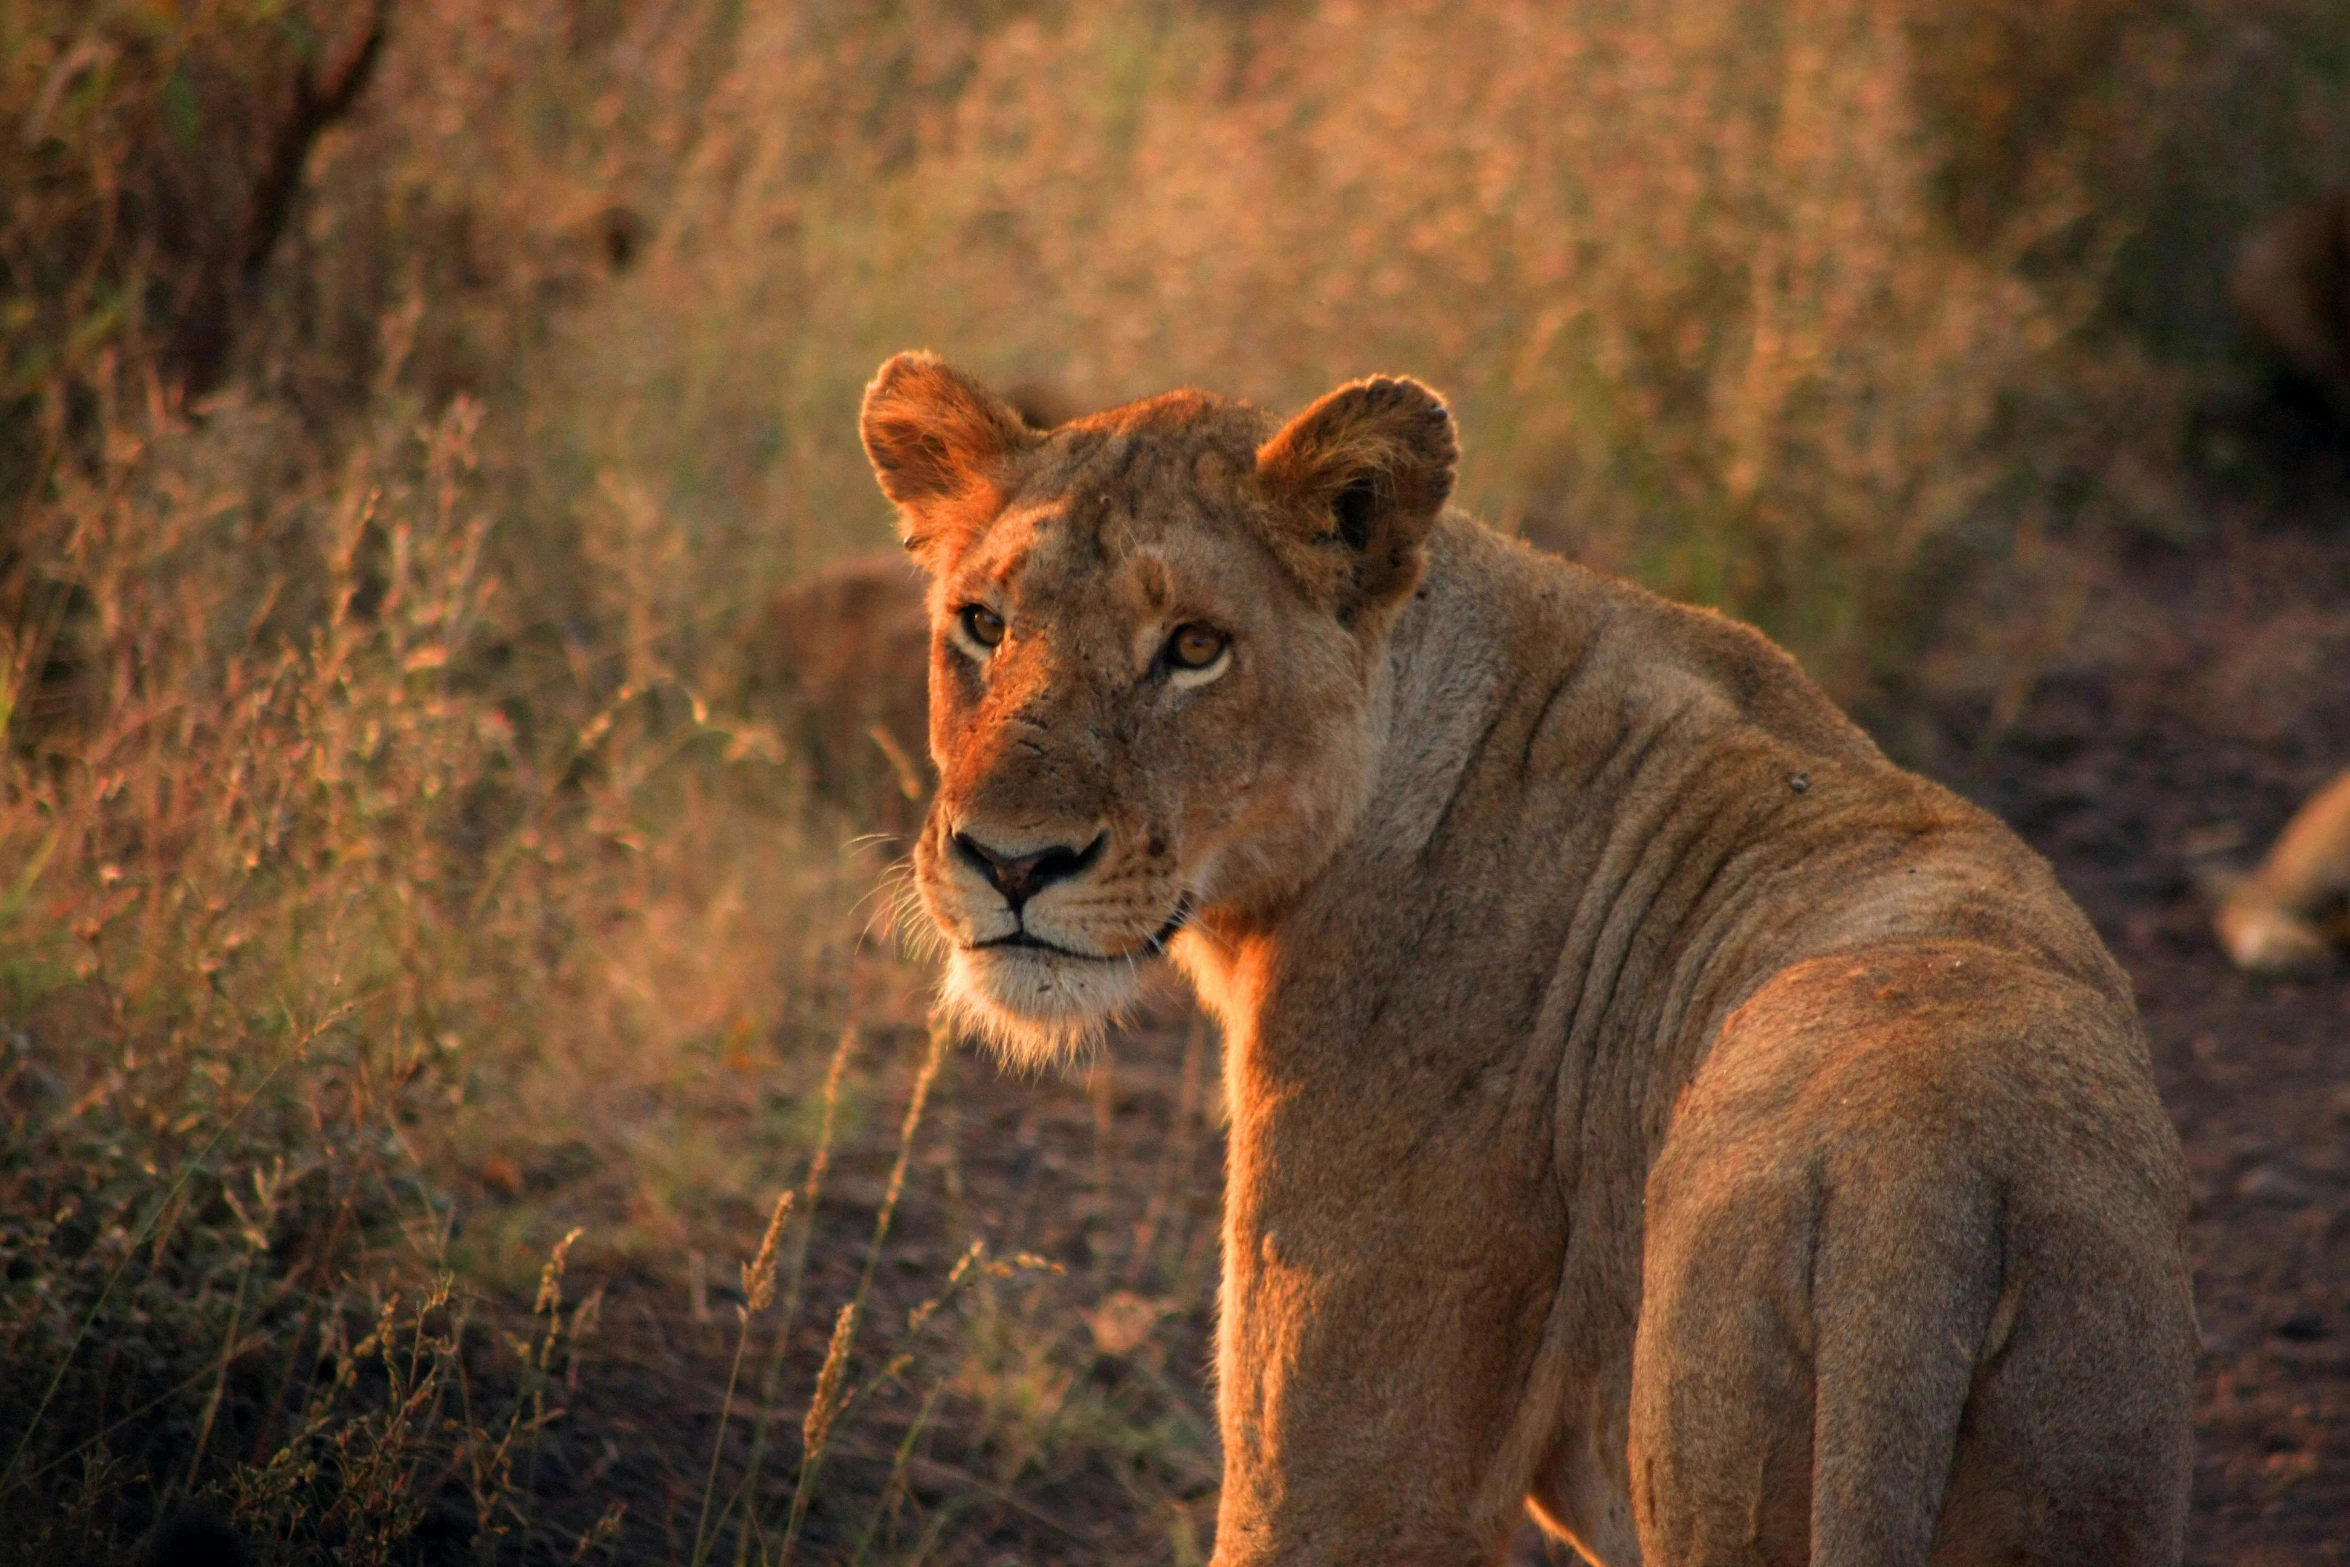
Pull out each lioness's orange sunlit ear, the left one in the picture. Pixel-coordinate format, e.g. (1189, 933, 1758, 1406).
(858, 352, 1041, 554)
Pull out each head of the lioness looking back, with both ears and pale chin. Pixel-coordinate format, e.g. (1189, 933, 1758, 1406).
(865, 355, 1452, 1060)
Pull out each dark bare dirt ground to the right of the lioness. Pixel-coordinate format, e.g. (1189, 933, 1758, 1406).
(1951, 489, 2350, 1567)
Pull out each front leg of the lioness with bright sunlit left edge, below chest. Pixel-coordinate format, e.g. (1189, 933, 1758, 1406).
(1215, 1104, 1563, 1567)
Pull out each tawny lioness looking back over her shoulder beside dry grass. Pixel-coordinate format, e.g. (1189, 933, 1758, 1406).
(862, 355, 2195, 1567)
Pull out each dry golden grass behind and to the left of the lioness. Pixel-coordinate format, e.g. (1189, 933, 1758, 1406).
(0, 0, 2350, 1565)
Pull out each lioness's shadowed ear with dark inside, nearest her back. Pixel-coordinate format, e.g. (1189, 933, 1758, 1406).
(1257, 376, 1459, 616)
